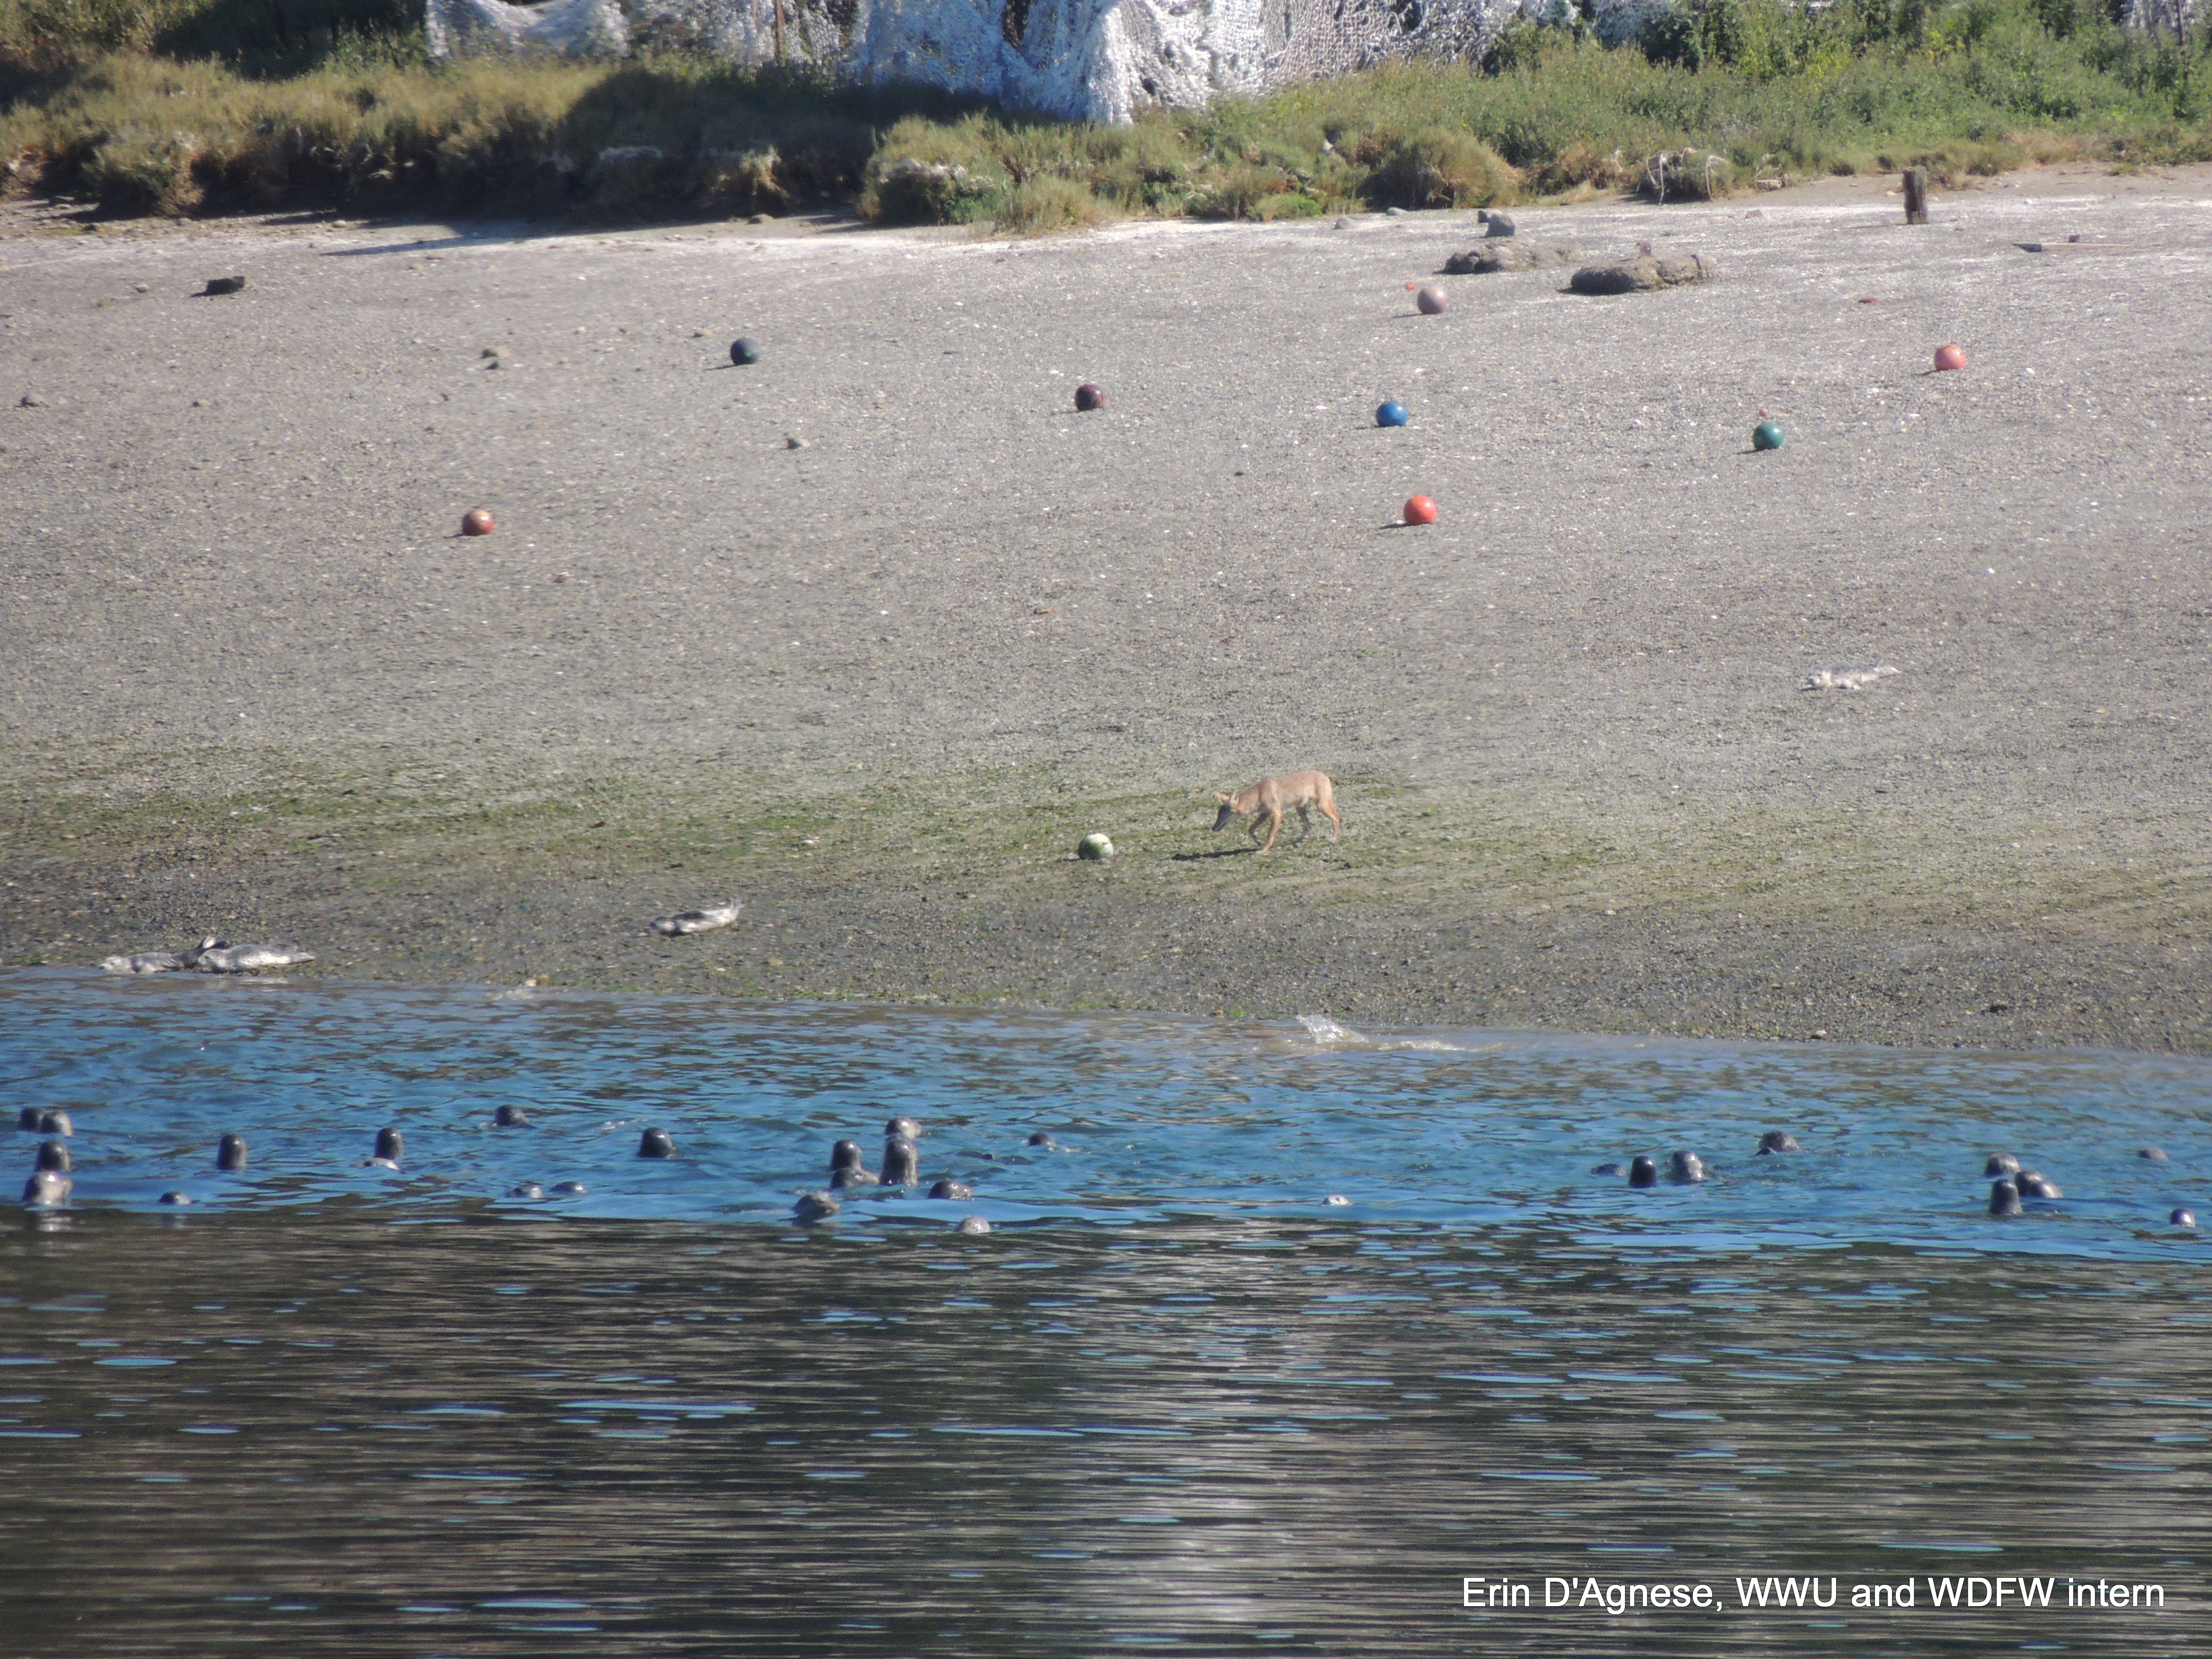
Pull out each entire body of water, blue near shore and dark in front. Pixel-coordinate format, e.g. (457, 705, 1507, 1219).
(0, 971, 2212, 1659)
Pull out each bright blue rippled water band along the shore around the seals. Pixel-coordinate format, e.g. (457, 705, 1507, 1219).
(0, 971, 2212, 1256)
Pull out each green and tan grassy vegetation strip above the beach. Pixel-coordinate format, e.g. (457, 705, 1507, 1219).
(0, 0, 2212, 224)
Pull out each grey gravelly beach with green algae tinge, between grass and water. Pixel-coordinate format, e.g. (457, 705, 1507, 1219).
(0, 170, 2212, 1048)
